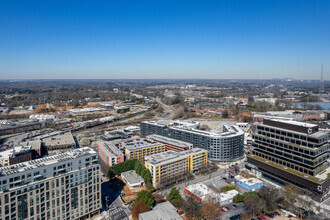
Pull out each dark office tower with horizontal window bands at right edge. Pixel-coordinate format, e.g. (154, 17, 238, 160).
(247, 119, 330, 198)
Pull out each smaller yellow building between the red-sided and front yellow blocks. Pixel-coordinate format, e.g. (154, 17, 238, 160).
(125, 139, 165, 164)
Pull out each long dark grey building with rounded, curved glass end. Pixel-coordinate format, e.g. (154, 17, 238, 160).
(140, 120, 244, 162)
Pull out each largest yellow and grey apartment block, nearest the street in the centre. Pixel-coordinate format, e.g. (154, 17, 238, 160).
(145, 148, 207, 187)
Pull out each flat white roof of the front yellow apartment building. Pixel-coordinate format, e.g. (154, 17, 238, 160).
(145, 147, 207, 165)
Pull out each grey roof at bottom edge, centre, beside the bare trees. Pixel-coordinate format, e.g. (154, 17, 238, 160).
(139, 201, 182, 220)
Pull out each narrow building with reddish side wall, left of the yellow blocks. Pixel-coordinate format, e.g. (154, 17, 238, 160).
(97, 141, 124, 171)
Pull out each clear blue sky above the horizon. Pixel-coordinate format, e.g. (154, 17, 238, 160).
(0, 0, 330, 80)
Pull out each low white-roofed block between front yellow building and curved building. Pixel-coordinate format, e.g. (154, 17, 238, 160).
(146, 134, 193, 151)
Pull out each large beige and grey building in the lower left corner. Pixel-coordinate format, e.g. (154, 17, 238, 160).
(0, 148, 101, 220)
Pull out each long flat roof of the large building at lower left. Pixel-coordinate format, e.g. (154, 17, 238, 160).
(0, 147, 96, 176)
